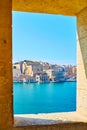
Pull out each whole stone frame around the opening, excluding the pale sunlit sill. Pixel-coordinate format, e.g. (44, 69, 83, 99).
(0, 0, 87, 130)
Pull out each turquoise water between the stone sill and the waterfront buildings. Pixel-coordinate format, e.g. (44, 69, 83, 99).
(14, 82, 76, 114)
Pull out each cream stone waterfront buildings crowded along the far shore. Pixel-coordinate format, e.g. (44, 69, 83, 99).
(13, 60, 76, 83)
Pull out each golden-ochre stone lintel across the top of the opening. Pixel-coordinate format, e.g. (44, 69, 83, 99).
(12, 0, 87, 16)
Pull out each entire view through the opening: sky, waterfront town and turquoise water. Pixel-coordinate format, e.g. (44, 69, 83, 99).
(13, 12, 77, 114)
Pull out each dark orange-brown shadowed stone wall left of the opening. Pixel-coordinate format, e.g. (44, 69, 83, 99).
(0, 0, 13, 130)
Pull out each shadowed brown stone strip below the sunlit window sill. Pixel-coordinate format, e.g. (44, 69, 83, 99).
(6, 123, 87, 130)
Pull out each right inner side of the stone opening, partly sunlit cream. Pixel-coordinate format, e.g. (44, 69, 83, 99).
(77, 8, 87, 116)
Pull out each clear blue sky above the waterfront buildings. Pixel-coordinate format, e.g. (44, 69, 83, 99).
(12, 12, 76, 65)
